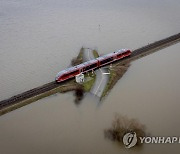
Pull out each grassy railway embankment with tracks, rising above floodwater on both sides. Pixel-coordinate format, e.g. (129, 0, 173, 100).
(0, 33, 180, 115)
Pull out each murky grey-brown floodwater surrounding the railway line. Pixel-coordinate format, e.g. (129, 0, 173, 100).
(0, 0, 180, 154)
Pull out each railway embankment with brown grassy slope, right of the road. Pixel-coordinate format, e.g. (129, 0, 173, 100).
(101, 33, 180, 99)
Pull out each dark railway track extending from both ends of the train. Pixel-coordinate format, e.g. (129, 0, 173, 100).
(0, 33, 180, 111)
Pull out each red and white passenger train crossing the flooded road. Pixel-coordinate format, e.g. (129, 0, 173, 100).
(55, 49, 132, 82)
